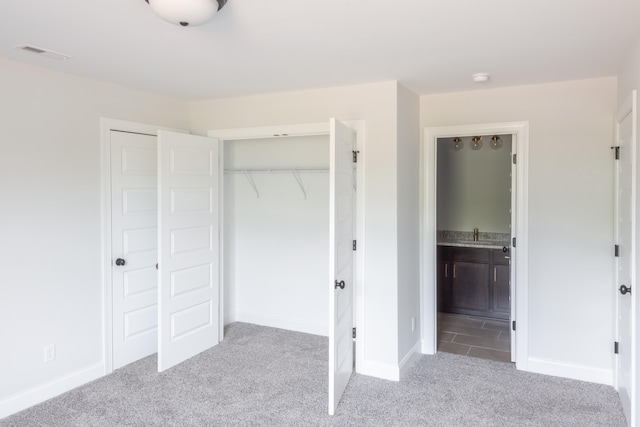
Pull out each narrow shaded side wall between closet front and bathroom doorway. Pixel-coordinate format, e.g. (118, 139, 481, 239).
(397, 85, 420, 370)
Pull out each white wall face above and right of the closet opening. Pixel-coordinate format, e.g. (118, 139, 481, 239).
(191, 82, 408, 378)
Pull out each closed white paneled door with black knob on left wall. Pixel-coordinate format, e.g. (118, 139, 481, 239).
(110, 130, 158, 369)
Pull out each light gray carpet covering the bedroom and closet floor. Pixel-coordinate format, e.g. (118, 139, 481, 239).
(0, 323, 626, 427)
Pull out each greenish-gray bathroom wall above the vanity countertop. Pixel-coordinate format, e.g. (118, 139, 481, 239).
(437, 135, 511, 233)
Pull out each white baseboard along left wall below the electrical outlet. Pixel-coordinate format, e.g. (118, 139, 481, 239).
(0, 362, 105, 419)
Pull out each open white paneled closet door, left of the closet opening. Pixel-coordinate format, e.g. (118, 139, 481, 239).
(158, 131, 220, 372)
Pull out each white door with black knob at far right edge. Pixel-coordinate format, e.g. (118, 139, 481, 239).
(614, 91, 637, 425)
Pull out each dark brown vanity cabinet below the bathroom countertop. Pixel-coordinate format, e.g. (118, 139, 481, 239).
(437, 246, 510, 319)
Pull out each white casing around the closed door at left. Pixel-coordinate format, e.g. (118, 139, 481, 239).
(100, 117, 188, 375)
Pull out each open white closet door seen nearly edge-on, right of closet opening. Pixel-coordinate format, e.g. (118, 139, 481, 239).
(329, 119, 354, 415)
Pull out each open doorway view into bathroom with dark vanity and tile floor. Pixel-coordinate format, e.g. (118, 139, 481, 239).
(436, 134, 513, 362)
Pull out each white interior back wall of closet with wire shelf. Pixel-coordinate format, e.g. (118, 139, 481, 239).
(224, 135, 329, 335)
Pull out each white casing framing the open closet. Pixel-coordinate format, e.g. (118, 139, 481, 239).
(207, 118, 367, 372)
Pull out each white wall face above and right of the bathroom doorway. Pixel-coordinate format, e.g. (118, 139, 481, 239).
(421, 78, 616, 383)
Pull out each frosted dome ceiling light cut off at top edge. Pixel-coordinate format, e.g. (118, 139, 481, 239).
(145, 0, 227, 27)
